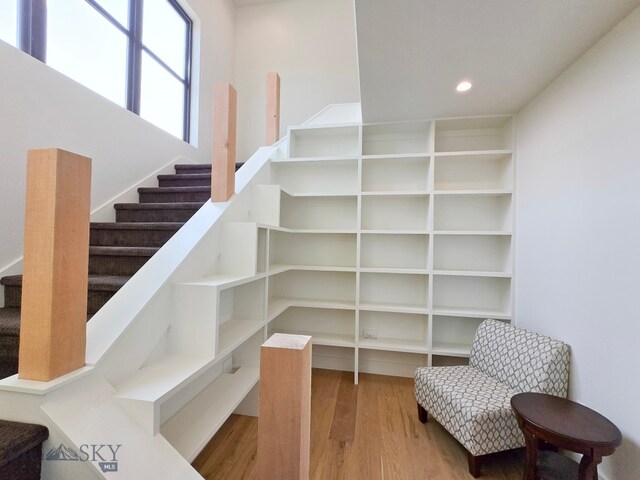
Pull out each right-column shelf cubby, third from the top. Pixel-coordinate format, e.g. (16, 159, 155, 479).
(433, 194, 512, 232)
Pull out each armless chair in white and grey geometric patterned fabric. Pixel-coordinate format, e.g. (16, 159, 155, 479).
(415, 320, 570, 477)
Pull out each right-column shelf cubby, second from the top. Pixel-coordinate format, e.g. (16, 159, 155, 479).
(434, 153, 513, 191)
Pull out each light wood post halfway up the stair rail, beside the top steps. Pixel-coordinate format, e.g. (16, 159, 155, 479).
(211, 83, 237, 202)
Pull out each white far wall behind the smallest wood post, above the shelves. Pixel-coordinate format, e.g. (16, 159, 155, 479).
(235, 0, 360, 161)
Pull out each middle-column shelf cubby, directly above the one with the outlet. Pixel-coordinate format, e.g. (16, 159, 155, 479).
(360, 273, 429, 313)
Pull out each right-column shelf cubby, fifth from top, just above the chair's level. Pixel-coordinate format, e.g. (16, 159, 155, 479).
(433, 275, 511, 318)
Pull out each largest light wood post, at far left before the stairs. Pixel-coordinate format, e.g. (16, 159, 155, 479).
(18, 149, 91, 381)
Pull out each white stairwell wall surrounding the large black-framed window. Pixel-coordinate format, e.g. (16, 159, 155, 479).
(0, 0, 235, 282)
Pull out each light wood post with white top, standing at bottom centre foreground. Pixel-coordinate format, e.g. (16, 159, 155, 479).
(257, 333, 311, 480)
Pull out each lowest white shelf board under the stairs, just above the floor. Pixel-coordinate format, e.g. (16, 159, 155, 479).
(160, 367, 260, 462)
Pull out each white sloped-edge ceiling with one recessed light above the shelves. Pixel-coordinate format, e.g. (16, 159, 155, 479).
(355, 0, 640, 122)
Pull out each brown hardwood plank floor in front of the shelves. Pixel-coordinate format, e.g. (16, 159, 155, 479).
(193, 369, 523, 480)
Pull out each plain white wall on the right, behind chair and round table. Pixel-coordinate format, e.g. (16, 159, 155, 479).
(516, 7, 640, 480)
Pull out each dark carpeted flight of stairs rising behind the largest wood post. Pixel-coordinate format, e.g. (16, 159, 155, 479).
(0, 164, 220, 378)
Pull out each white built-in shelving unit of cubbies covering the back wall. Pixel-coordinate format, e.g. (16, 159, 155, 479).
(266, 116, 515, 381)
